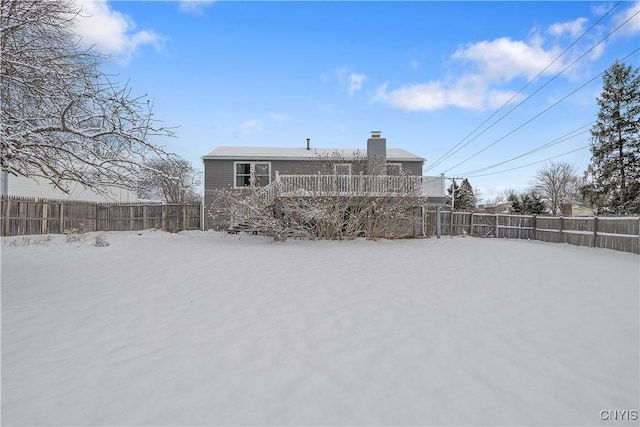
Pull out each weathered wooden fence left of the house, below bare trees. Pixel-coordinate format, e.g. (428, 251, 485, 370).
(0, 197, 201, 236)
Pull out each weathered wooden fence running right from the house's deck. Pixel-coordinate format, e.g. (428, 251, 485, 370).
(425, 211, 640, 254)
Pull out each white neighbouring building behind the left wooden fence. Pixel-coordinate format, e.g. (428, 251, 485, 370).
(0, 172, 138, 203)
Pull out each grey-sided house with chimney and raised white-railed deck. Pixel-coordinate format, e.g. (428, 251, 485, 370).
(202, 131, 446, 236)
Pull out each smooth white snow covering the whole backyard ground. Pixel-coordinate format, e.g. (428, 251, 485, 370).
(2, 230, 640, 426)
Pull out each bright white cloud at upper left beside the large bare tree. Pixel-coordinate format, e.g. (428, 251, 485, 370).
(75, 0, 162, 62)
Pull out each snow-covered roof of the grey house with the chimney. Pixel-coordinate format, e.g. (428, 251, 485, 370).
(202, 146, 425, 162)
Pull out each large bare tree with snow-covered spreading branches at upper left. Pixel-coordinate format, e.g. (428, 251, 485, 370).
(0, 0, 173, 196)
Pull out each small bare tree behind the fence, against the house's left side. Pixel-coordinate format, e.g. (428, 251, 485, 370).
(139, 156, 201, 203)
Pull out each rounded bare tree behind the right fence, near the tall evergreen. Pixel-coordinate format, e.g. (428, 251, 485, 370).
(533, 162, 579, 215)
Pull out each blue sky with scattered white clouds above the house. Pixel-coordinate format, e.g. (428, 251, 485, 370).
(72, 0, 640, 201)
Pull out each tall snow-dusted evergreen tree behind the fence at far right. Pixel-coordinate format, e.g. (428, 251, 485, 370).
(583, 61, 640, 214)
